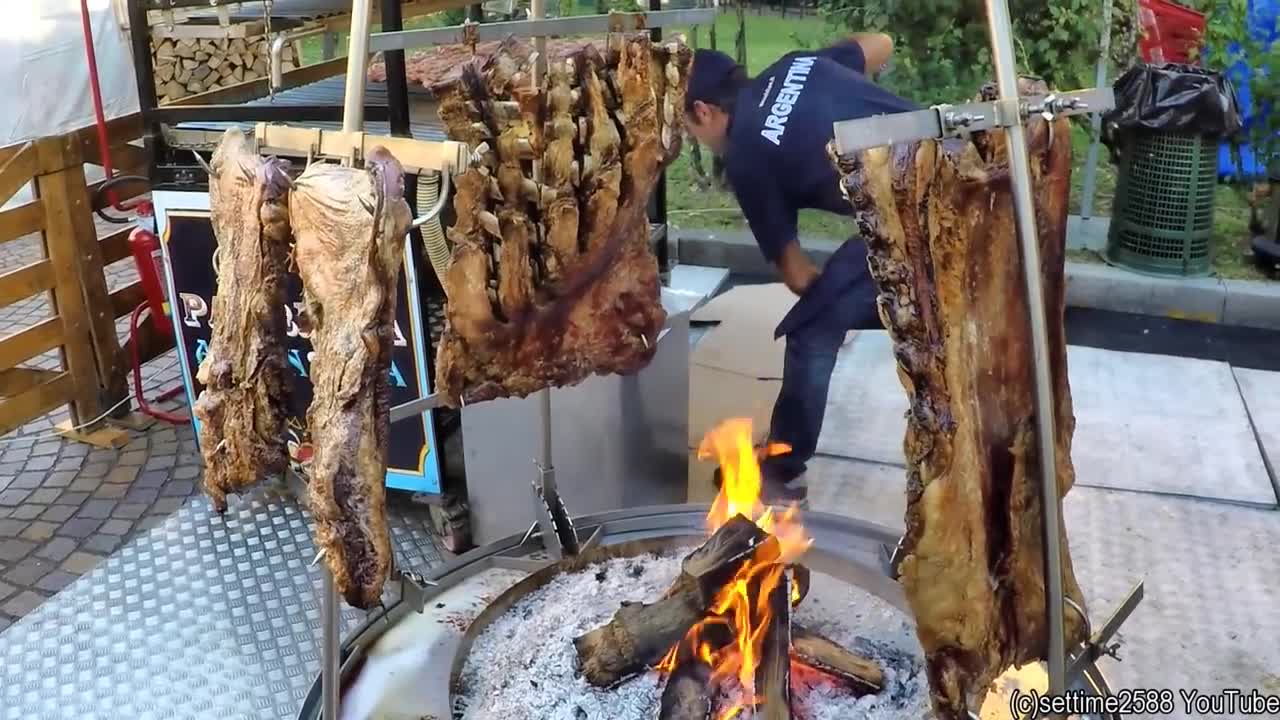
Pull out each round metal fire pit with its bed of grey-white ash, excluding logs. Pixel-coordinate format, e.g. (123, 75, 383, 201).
(300, 505, 1110, 720)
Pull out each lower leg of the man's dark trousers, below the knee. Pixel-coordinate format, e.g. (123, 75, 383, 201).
(760, 323, 846, 483)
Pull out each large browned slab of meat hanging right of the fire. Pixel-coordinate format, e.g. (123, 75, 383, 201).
(837, 75, 1084, 720)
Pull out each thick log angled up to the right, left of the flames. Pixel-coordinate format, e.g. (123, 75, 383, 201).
(573, 515, 767, 688)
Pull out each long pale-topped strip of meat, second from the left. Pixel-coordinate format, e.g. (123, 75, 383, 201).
(289, 147, 411, 609)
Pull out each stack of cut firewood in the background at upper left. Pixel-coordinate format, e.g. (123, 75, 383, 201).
(151, 35, 300, 105)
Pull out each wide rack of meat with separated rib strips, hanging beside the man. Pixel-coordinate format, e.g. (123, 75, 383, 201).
(433, 33, 692, 406)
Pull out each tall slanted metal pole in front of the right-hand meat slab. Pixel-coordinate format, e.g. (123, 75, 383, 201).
(987, 0, 1066, 696)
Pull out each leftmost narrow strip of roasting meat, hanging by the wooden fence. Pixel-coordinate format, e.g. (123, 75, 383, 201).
(193, 129, 291, 512)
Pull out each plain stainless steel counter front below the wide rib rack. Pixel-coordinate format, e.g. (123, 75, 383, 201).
(462, 285, 689, 544)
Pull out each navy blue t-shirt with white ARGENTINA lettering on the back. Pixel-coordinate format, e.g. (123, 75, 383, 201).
(724, 41, 918, 264)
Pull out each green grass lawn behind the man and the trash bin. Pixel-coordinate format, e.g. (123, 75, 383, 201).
(302, 6, 1265, 279)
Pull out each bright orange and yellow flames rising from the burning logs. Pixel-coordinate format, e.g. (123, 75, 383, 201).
(658, 419, 813, 720)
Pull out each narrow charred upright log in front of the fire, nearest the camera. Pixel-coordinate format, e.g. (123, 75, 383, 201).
(753, 565, 791, 720)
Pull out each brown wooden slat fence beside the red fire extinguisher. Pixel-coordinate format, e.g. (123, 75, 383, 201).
(0, 117, 166, 446)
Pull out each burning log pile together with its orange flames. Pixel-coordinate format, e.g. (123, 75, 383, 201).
(575, 419, 883, 720)
